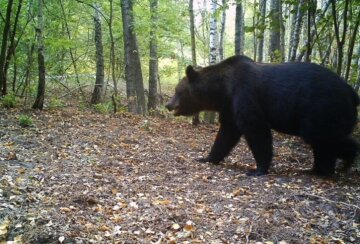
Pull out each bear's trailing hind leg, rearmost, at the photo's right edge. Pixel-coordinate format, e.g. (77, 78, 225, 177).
(336, 138, 359, 170)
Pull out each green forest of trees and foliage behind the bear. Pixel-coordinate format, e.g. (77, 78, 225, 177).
(0, 0, 360, 117)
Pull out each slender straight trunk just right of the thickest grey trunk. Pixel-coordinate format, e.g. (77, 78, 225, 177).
(148, 0, 159, 111)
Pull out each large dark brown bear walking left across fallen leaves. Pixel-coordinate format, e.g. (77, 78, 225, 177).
(166, 55, 359, 176)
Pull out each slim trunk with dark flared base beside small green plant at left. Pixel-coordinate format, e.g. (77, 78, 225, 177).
(32, 0, 45, 110)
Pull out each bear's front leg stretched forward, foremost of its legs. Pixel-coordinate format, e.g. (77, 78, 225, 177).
(197, 116, 241, 164)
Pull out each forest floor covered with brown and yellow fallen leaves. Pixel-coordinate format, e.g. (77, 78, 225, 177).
(0, 108, 360, 244)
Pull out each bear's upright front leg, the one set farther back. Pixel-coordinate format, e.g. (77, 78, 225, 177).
(245, 128, 273, 176)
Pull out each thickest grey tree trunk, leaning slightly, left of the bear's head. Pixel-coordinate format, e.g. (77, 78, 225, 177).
(120, 0, 146, 115)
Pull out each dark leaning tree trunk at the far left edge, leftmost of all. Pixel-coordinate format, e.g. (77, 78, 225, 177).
(0, 0, 13, 96)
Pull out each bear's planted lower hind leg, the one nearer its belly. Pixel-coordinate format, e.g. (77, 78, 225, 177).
(312, 143, 337, 176)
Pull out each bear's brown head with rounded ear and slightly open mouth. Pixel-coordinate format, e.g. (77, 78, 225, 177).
(165, 65, 204, 116)
